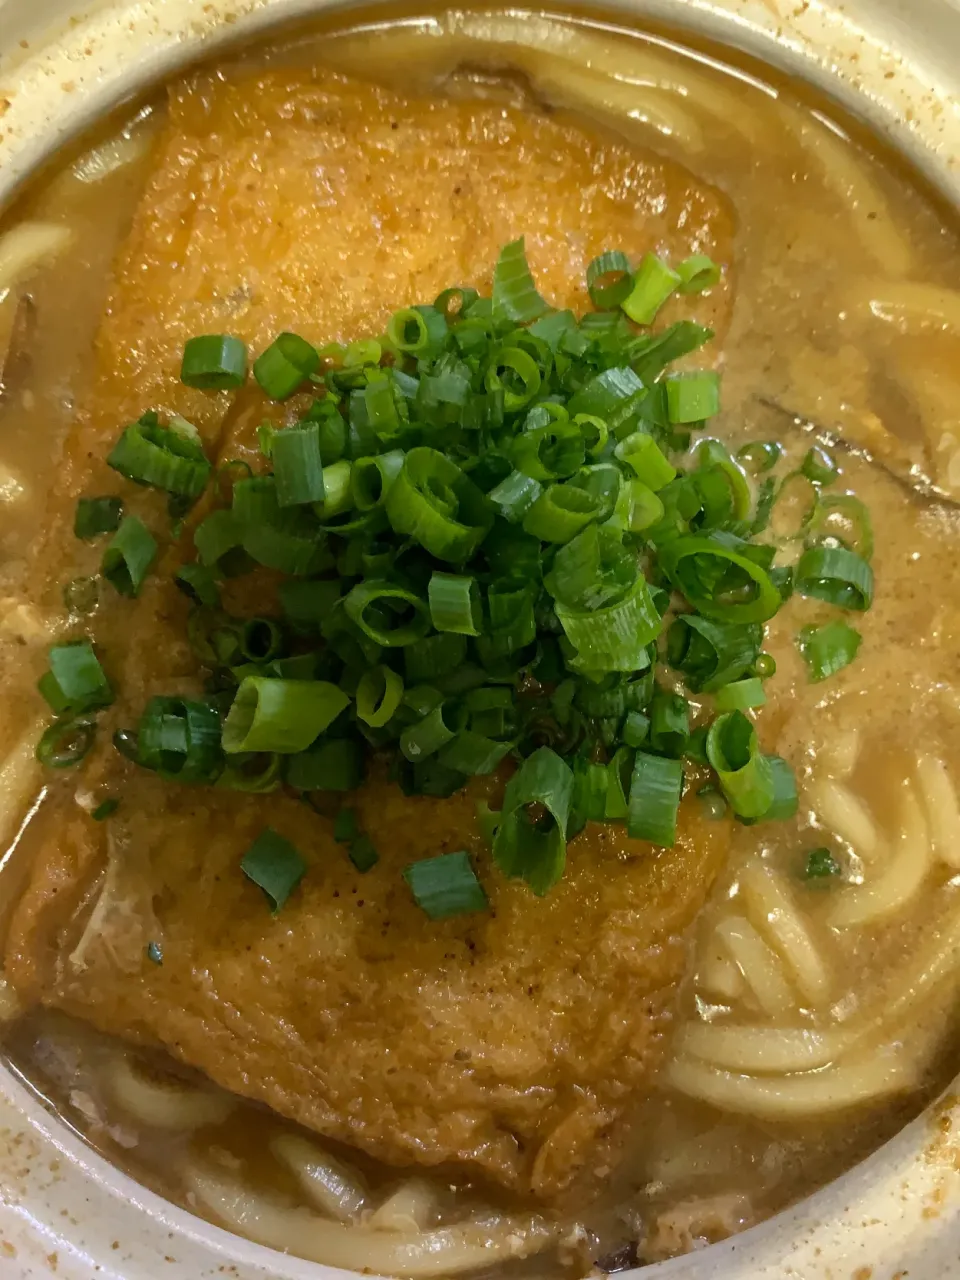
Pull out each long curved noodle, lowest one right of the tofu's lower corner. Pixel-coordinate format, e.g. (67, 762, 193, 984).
(667, 1048, 916, 1120)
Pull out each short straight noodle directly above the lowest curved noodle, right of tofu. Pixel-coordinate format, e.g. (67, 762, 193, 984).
(677, 1023, 855, 1075)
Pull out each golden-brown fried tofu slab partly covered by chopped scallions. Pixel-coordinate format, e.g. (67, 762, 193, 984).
(5, 62, 732, 1201)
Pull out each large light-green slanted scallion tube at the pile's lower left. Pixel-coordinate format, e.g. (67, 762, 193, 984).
(223, 676, 349, 755)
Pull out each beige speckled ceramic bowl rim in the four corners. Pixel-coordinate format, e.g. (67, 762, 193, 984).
(0, 0, 960, 1280)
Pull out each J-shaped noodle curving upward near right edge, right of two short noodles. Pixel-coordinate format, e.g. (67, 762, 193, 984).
(827, 786, 933, 929)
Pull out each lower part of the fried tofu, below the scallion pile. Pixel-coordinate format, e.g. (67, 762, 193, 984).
(6, 777, 728, 1197)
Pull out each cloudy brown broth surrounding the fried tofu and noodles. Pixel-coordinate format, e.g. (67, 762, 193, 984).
(0, 10, 960, 1270)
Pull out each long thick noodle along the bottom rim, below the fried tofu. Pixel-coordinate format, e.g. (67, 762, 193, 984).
(183, 1166, 557, 1277)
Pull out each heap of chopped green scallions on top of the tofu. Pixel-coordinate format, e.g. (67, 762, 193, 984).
(38, 241, 873, 916)
